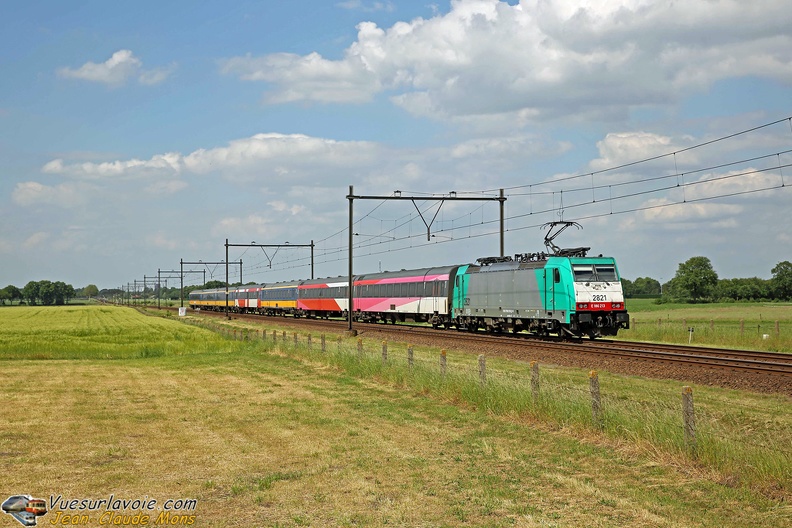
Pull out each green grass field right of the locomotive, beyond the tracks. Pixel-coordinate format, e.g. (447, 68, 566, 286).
(619, 299, 792, 353)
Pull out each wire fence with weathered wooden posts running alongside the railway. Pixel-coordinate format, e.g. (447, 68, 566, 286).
(187, 316, 792, 490)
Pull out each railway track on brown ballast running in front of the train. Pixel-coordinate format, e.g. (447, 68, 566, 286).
(148, 306, 792, 395)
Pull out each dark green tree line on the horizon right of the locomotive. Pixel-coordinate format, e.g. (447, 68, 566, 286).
(622, 257, 792, 302)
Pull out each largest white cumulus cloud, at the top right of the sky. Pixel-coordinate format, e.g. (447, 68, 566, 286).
(221, 0, 792, 121)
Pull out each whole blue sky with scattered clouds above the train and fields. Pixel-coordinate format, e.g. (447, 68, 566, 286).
(0, 0, 792, 288)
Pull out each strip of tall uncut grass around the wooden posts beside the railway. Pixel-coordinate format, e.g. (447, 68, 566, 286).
(224, 318, 792, 496)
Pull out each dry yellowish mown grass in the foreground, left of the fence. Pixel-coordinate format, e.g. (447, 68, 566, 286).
(0, 306, 792, 527)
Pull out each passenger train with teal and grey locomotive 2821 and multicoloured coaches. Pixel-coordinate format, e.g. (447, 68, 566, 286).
(189, 223, 630, 339)
